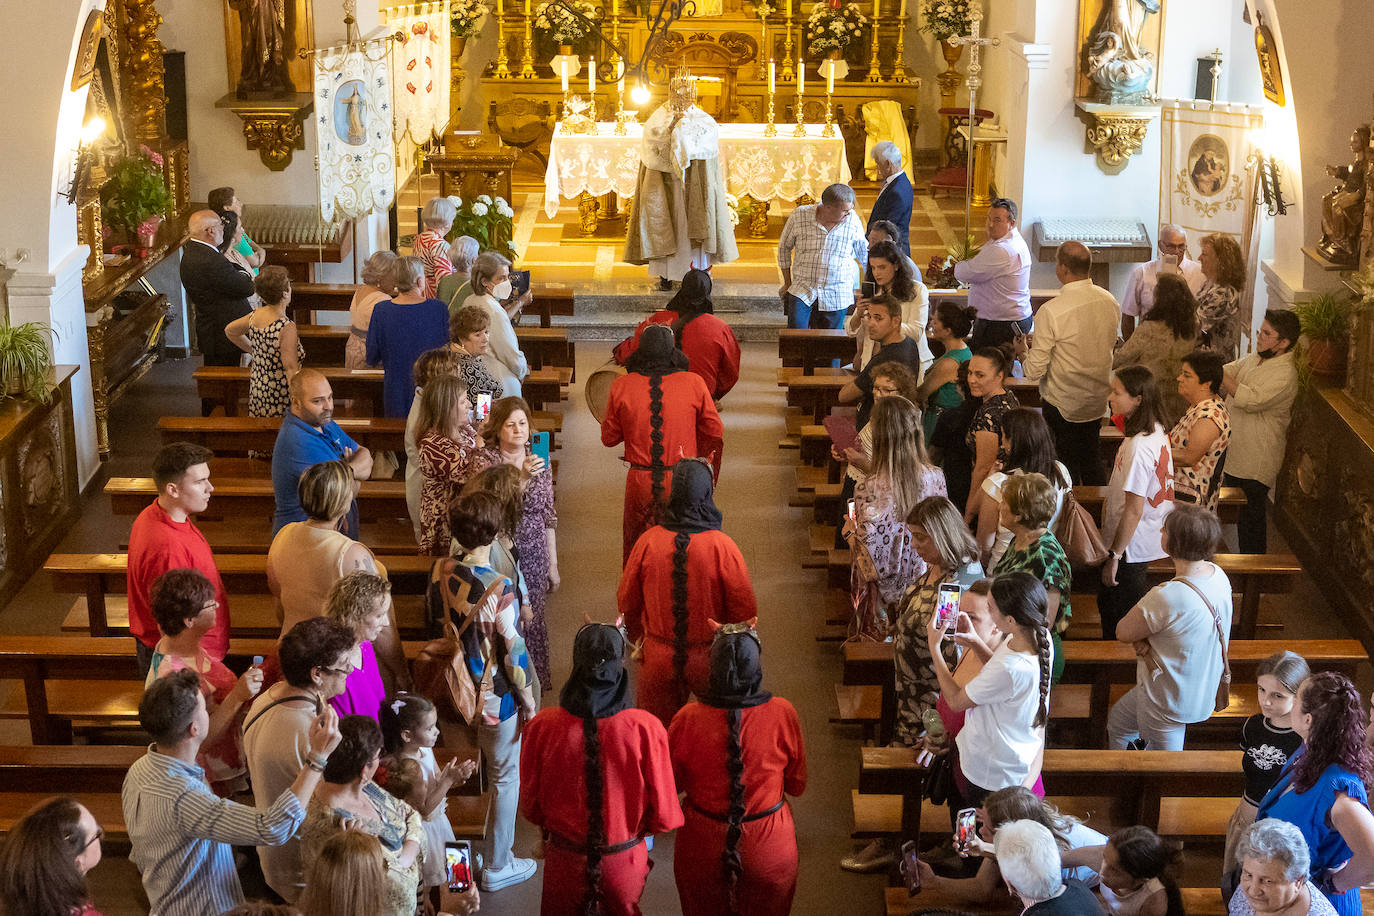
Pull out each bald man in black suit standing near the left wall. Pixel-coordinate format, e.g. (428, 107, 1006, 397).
(181, 210, 253, 395)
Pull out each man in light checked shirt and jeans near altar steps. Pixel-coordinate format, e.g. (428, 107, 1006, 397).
(778, 184, 868, 333)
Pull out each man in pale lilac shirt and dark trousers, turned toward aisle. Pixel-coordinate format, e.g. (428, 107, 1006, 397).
(954, 198, 1031, 350)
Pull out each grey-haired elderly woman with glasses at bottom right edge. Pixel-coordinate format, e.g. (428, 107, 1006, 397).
(1230, 817, 1336, 916)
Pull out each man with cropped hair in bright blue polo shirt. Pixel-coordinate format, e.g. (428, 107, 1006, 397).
(272, 369, 372, 540)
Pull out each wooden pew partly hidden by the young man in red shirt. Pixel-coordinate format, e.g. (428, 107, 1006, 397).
(43, 553, 434, 636)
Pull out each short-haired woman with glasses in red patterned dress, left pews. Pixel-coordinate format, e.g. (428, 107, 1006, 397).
(146, 570, 262, 798)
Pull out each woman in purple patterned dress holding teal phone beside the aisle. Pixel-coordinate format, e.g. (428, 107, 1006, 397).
(482, 397, 561, 691)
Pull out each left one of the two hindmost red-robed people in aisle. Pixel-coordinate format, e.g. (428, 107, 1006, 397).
(519, 623, 683, 916)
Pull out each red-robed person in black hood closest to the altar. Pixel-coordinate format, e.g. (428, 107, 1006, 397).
(614, 269, 739, 401)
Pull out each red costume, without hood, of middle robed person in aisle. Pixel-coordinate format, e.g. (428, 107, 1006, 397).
(616, 527, 758, 725)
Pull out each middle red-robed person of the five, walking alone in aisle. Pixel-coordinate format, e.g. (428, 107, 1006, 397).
(616, 459, 758, 726)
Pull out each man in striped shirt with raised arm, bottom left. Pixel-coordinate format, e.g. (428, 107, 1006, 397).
(122, 669, 339, 916)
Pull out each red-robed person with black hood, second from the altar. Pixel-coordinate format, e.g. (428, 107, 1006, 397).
(602, 324, 725, 562)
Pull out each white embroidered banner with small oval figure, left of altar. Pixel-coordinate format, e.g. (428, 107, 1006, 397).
(315, 45, 396, 222)
